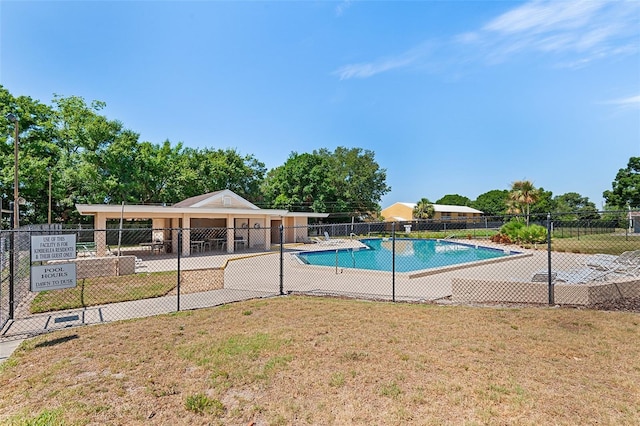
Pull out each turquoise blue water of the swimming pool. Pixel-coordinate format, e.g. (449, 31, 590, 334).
(297, 238, 515, 272)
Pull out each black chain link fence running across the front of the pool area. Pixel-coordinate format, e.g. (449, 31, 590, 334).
(0, 211, 640, 339)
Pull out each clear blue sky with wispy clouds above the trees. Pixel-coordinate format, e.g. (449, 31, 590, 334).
(0, 0, 640, 208)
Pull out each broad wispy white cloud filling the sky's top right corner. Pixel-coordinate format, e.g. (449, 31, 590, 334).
(468, 0, 640, 65)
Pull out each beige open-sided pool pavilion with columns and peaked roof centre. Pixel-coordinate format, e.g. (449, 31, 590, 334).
(76, 189, 328, 256)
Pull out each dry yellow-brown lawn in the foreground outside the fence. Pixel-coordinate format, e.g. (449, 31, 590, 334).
(0, 296, 640, 425)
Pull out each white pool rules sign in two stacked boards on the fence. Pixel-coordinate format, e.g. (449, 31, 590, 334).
(31, 234, 76, 291)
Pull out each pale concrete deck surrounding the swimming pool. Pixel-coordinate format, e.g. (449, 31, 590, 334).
(132, 239, 581, 301)
